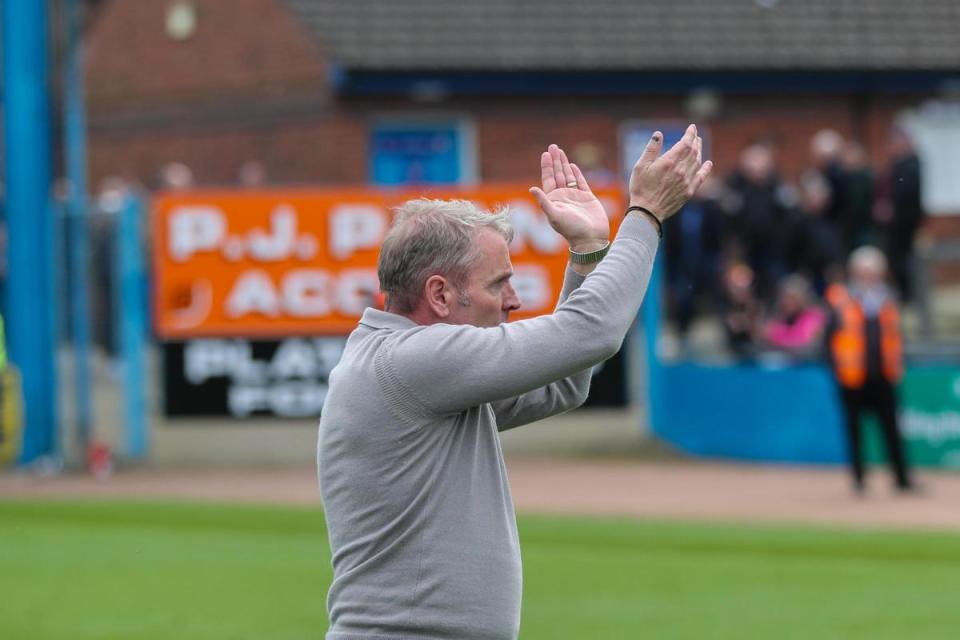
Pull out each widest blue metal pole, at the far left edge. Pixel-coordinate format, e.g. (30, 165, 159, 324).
(3, 0, 57, 462)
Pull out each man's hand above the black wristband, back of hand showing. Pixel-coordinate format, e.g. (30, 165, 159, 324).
(630, 124, 713, 220)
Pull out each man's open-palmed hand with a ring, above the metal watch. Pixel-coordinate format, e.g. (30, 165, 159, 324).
(530, 144, 610, 252)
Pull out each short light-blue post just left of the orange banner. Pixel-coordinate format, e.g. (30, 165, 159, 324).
(114, 194, 149, 458)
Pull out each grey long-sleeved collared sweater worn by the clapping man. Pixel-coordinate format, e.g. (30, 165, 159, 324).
(317, 214, 657, 640)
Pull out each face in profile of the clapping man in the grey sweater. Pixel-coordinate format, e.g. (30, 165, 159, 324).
(447, 228, 520, 327)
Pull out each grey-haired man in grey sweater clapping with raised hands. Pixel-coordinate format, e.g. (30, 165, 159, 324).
(318, 125, 711, 640)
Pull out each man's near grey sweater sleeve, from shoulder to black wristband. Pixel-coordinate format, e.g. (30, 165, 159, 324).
(377, 214, 658, 415)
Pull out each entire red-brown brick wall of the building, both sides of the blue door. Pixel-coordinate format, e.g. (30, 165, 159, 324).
(87, 0, 952, 238)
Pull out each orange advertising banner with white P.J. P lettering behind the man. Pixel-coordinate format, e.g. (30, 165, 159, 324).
(153, 185, 622, 340)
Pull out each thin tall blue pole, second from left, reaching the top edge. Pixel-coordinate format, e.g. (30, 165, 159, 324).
(64, 0, 93, 451)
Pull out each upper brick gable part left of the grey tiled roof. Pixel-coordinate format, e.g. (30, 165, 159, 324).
(87, 0, 326, 111)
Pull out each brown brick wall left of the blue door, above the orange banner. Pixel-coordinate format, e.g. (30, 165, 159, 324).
(86, 0, 344, 189)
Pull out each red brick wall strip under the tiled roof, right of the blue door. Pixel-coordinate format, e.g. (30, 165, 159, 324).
(376, 95, 924, 188)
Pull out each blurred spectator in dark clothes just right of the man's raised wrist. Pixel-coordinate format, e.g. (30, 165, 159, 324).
(663, 179, 723, 340)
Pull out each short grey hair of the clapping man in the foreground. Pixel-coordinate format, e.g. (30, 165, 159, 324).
(377, 198, 513, 313)
